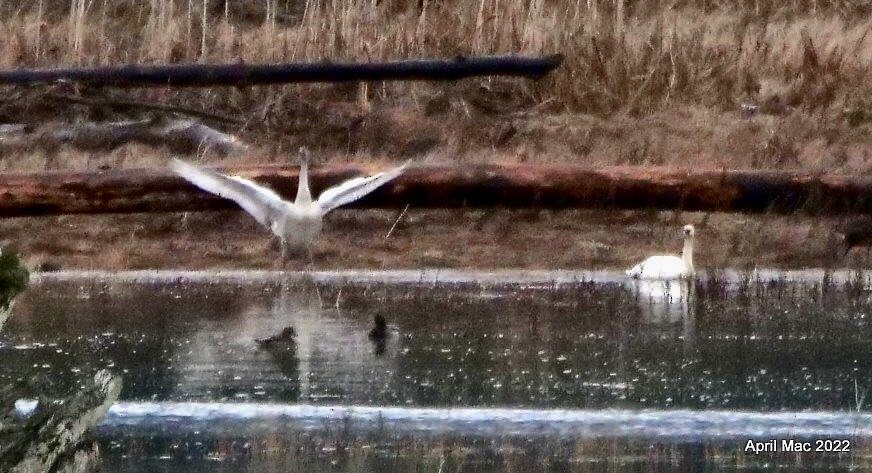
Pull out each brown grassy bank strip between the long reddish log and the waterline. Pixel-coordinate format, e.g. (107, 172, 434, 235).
(0, 209, 872, 269)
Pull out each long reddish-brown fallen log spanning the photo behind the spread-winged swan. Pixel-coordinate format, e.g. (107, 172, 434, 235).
(0, 164, 872, 217)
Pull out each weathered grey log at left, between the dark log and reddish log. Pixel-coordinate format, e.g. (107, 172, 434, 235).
(0, 119, 247, 156)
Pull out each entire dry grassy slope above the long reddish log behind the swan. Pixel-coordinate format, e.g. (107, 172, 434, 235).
(0, 0, 872, 172)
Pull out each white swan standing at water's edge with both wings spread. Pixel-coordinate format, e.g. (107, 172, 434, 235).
(170, 148, 409, 263)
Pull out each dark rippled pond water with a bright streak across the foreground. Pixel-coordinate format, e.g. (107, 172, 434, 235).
(0, 273, 872, 471)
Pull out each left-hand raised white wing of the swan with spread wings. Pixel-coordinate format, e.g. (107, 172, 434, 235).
(170, 159, 286, 228)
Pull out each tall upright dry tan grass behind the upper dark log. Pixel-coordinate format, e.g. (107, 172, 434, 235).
(0, 0, 872, 119)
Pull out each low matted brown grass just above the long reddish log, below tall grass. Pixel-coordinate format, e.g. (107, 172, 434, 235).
(0, 104, 872, 174)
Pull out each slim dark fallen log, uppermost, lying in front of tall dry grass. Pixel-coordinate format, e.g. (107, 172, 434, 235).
(0, 54, 563, 87)
